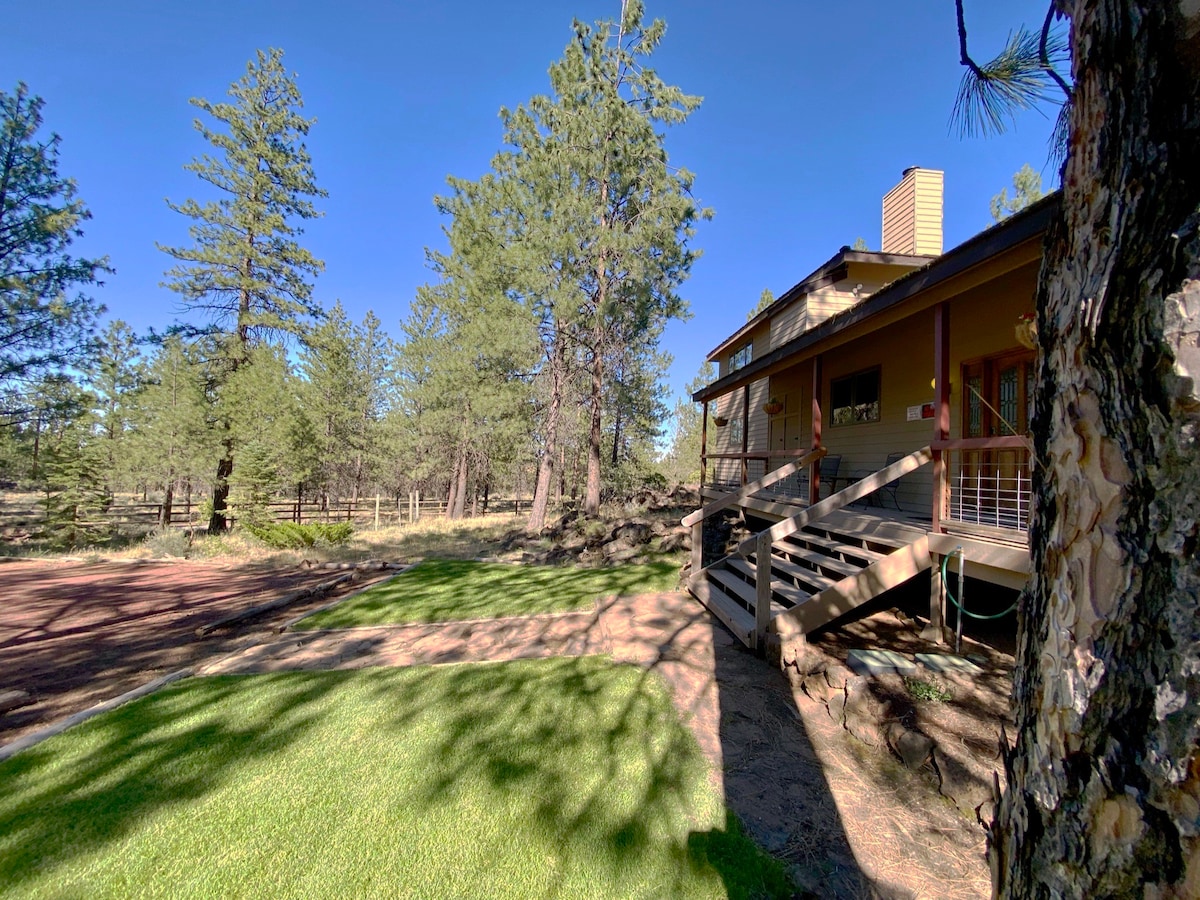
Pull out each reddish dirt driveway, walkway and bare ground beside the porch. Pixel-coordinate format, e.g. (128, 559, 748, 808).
(0, 554, 1010, 899)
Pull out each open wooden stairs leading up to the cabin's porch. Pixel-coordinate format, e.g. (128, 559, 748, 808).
(689, 511, 930, 648)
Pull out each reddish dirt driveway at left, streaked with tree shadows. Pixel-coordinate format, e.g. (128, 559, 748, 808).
(0, 560, 388, 744)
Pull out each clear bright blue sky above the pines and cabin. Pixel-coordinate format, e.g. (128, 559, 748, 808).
(7, 0, 1055, 405)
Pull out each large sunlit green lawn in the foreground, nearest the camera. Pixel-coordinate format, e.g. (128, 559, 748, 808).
(0, 658, 790, 900)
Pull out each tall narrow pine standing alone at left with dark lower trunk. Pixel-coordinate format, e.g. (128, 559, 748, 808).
(160, 49, 325, 532)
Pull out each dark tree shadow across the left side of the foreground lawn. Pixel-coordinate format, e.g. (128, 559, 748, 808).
(0, 678, 338, 888)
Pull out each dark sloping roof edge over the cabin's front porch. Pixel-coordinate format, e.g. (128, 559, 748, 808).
(691, 191, 1062, 402)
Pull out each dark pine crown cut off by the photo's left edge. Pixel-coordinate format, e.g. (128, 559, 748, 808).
(0, 84, 112, 424)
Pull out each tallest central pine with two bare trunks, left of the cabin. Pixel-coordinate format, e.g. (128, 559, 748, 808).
(493, 0, 710, 520)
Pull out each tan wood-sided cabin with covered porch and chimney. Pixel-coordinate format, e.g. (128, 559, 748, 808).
(683, 167, 1058, 648)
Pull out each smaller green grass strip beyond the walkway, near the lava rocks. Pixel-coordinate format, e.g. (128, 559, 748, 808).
(296, 559, 679, 629)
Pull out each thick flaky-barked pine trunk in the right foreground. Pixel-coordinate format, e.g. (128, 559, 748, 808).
(991, 0, 1200, 900)
